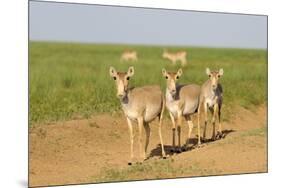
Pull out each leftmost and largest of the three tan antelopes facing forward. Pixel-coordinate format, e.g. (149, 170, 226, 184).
(109, 67, 166, 165)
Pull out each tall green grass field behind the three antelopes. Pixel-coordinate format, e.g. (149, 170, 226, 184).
(29, 42, 267, 125)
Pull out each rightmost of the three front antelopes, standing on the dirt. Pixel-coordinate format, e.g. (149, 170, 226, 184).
(198, 68, 223, 140)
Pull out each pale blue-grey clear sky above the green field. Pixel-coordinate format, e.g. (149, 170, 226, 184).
(29, 1, 267, 49)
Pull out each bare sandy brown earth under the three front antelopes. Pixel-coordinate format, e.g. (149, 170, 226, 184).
(29, 106, 267, 186)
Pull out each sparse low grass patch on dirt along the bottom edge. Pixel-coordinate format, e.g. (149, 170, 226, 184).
(90, 159, 220, 182)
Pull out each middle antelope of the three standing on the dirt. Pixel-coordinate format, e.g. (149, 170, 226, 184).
(162, 69, 200, 153)
